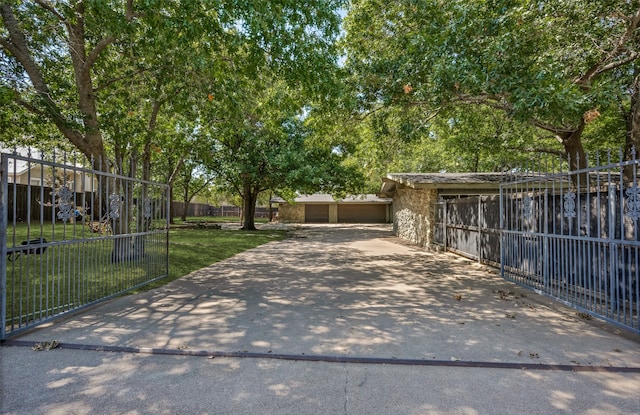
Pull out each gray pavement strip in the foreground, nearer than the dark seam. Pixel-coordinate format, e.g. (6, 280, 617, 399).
(0, 348, 640, 415)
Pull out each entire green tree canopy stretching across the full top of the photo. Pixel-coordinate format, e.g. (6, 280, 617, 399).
(0, 0, 640, 218)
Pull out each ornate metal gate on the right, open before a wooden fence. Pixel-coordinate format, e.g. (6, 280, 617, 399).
(500, 150, 640, 332)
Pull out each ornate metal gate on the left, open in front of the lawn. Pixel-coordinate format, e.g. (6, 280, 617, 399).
(0, 151, 169, 340)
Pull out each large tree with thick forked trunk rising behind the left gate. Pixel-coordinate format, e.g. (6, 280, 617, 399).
(0, 0, 350, 171)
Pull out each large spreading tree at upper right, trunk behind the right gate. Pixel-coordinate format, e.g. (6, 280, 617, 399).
(346, 0, 640, 169)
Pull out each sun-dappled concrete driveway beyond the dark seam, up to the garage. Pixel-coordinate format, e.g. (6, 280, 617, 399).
(17, 226, 640, 366)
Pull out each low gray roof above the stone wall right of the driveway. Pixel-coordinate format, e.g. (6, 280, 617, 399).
(378, 173, 503, 197)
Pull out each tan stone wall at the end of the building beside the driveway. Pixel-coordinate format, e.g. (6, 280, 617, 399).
(393, 188, 438, 248)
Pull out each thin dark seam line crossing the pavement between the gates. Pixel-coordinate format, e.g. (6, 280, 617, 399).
(5, 340, 640, 373)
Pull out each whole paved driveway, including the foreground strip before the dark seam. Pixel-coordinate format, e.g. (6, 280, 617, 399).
(0, 225, 640, 414)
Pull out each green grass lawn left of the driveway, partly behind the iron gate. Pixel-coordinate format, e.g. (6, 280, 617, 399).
(6, 219, 286, 331)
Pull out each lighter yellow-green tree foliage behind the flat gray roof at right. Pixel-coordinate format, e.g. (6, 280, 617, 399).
(338, 105, 562, 192)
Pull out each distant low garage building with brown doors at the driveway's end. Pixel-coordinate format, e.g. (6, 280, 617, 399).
(271, 193, 392, 223)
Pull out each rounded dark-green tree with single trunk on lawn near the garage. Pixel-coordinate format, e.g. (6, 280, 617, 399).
(199, 77, 361, 230)
